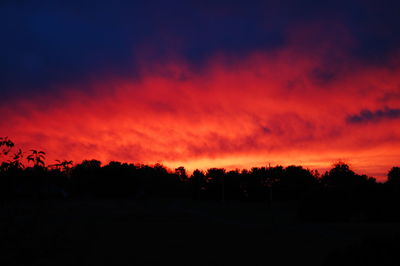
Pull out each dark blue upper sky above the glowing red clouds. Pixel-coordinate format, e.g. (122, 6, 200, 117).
(0, 0, 400, 99)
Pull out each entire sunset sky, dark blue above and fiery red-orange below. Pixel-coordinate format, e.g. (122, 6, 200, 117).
(0, 0, 400, 180)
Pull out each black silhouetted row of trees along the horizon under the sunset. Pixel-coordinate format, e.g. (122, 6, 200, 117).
(0, 138, 400, 220)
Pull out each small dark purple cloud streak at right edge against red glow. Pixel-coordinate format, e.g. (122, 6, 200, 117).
(346, 107, 400, 124)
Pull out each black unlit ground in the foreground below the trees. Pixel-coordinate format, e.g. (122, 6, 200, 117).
(0, 199, 400, 266)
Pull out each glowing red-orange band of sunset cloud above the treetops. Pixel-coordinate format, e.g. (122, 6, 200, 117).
(0, 48, 400, 182)
